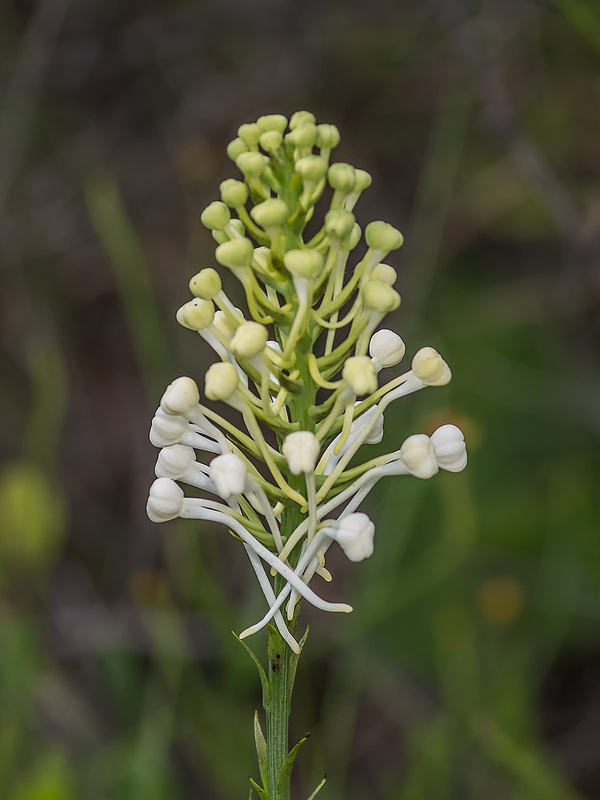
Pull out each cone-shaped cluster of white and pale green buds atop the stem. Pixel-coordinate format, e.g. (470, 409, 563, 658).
(147, 111, 467, 652)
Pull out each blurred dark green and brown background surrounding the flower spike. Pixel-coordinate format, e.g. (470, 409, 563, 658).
(0, 0, 600, 800)
